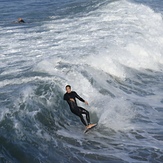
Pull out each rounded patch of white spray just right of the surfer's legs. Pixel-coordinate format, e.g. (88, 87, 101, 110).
(93, 97, 135, 131)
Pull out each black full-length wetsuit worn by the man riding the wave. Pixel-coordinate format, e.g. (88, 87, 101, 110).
(64, 91, 90, 126)
